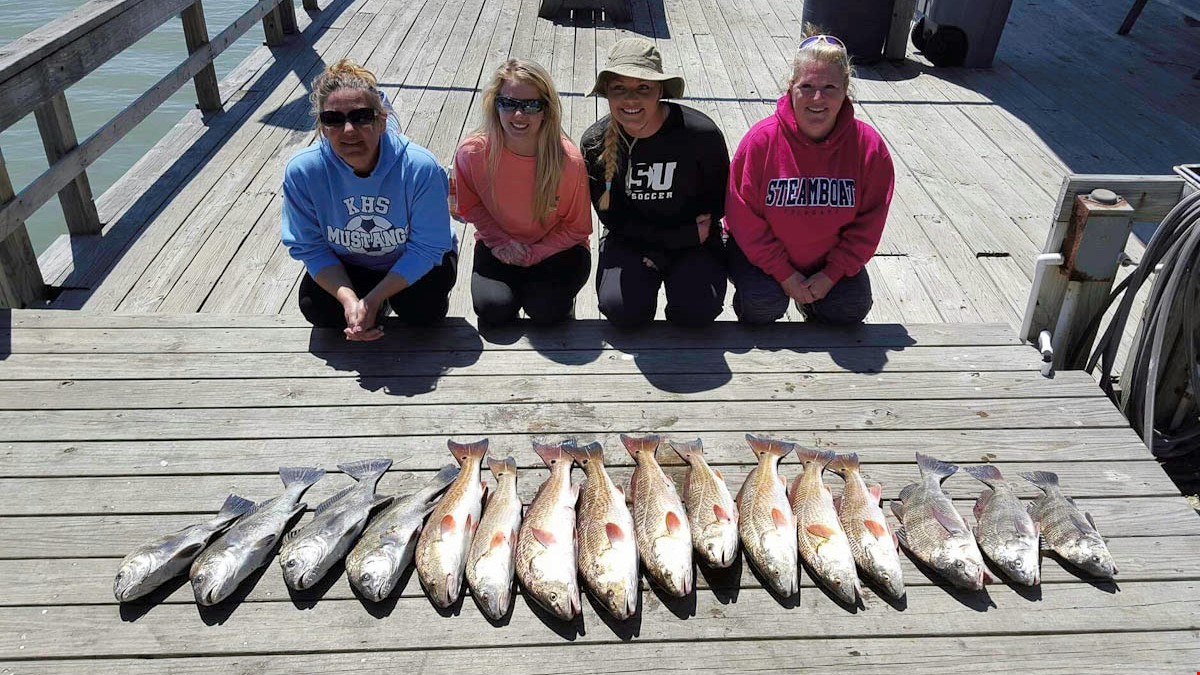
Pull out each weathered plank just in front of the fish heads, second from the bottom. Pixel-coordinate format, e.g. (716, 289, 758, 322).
(0, 581, 1200, 658)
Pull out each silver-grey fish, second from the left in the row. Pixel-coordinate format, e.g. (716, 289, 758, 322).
(191, 466, 325, 605)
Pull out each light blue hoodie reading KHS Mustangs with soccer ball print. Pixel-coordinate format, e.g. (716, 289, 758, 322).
(282, 117, 455, 285)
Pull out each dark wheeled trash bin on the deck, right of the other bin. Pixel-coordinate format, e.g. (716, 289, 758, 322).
(912, 0, 1013, 68)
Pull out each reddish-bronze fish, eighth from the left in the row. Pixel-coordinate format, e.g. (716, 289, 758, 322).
(570, 443, 641, 620)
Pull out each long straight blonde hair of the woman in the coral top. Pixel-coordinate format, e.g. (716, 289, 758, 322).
(475, 59, 566, 221)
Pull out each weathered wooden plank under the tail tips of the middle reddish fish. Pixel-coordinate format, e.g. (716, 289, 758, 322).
(0, 429, 1150, 478)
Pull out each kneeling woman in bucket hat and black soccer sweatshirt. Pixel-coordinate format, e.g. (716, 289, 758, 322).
(580, 37, 730, 327)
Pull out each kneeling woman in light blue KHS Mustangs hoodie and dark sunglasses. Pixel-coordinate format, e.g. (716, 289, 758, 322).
(283, 59, 458, 341)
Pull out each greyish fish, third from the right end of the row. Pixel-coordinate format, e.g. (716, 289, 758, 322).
(892, 453, 991, 591)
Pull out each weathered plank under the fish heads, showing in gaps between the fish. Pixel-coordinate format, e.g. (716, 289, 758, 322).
(7, 537, 1200, 611)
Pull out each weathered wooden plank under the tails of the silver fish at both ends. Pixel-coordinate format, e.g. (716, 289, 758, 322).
(0, 456, 1171, 514)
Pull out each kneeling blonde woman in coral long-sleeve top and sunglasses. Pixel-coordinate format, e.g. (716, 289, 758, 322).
(454, 59, 592, 325)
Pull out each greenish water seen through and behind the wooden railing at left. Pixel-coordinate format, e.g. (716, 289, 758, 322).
(0, 0, 263, 253)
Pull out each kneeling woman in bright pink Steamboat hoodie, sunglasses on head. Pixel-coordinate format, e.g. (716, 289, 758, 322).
(725, 35, 894, 324)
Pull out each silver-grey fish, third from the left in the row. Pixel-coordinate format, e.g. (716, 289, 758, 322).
(280, 459, 391, 591)
